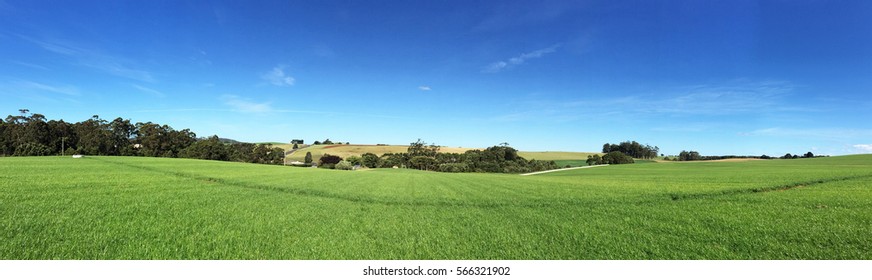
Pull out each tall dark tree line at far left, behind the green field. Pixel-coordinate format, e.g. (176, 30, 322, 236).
(0, 109, 284, 164)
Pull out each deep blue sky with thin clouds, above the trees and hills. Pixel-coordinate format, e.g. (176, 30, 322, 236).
(0, 0, 872, 155)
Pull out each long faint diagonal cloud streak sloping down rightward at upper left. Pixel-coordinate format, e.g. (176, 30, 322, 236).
(19, 36, 157, 83)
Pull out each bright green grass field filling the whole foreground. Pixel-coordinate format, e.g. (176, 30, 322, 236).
(0, 155, 872, 259)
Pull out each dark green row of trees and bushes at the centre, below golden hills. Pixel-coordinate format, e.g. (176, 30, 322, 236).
(306, 139, 559, 173)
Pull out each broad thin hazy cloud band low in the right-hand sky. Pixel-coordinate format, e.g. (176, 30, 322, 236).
(495, 81, 804, 123)
